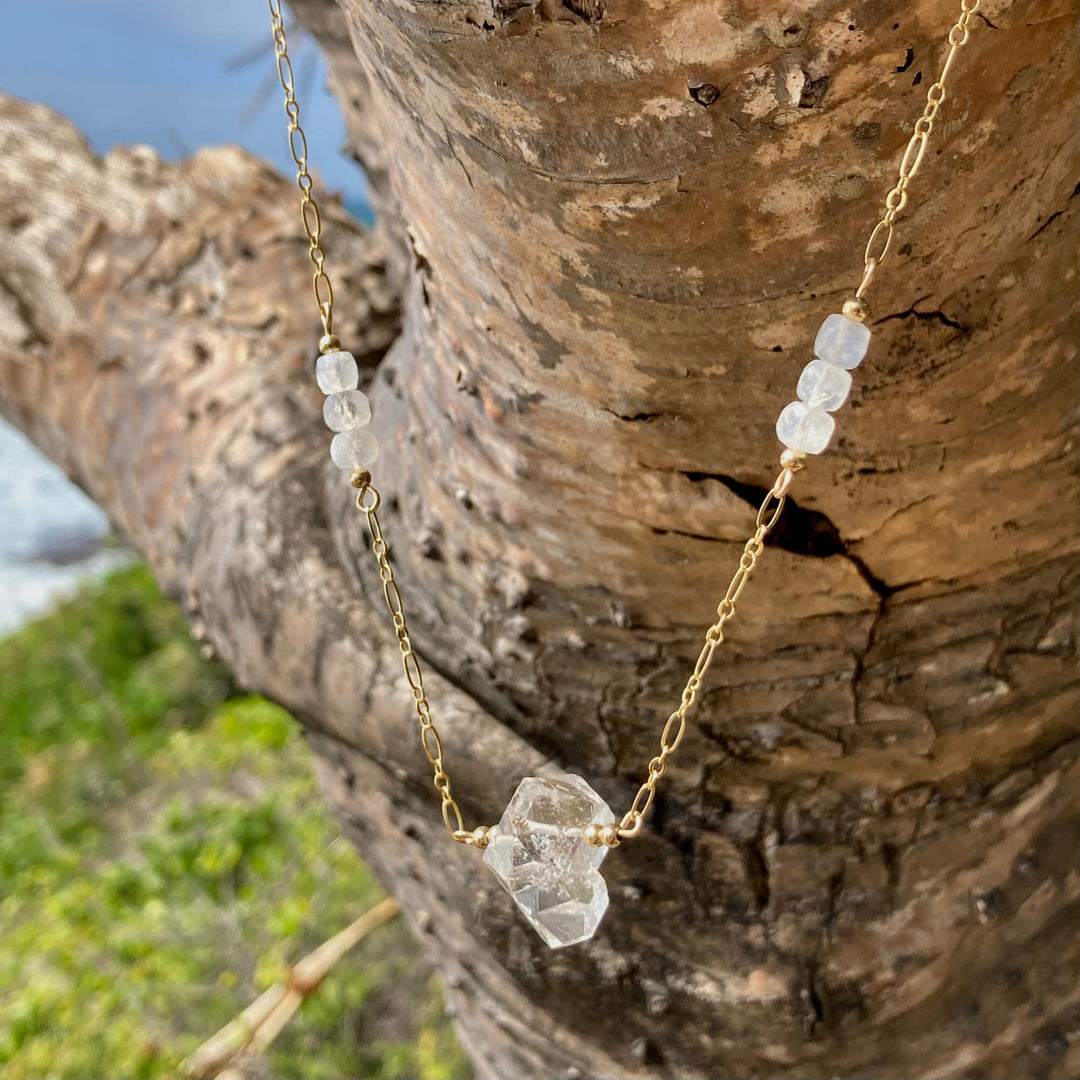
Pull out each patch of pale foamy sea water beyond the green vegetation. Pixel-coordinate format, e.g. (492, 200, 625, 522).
(0, 420, 135, 636)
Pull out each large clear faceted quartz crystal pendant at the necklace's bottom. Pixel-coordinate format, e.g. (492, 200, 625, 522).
(484, 773, 616, 948)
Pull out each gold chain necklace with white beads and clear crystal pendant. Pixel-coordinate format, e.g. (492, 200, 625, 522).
(268, 0, 980, 948)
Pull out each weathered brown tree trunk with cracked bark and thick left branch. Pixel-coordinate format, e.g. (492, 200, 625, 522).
(0, 0, 1080, 1078)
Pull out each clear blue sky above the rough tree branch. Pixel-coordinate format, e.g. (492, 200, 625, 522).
(0, 0, 364, 203)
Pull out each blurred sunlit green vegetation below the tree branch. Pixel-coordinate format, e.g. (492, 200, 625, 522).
(0, 566, 469, 1080)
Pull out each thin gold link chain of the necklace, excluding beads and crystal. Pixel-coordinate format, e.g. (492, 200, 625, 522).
(268, 0, 980, 848)
